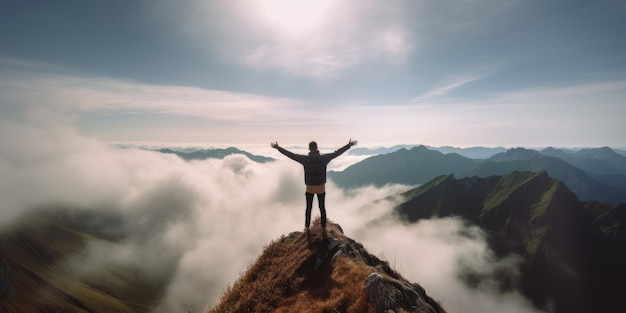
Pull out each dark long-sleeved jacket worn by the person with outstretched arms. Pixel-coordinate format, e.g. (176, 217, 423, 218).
(278, 144, 350, 186)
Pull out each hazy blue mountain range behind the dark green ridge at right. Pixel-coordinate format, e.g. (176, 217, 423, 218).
(329, 146, 626, 203)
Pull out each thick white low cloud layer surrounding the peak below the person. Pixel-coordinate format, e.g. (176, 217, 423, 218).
(0, 123, 533, 312)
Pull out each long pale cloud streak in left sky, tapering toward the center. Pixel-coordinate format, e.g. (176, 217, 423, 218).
(0, 73, 299, 122)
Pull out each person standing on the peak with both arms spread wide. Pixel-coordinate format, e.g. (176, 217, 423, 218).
(271, 139, 357, 230)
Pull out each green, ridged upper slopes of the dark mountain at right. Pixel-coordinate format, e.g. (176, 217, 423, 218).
(398, 172, 578, 256)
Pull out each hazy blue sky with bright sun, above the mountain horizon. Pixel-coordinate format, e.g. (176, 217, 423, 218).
(0, 0, 626, 148)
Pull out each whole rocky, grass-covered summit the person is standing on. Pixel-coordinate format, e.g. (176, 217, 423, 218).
(209, 221, 444, 313)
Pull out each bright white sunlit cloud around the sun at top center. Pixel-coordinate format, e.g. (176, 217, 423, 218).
(166, 0, 415, 79)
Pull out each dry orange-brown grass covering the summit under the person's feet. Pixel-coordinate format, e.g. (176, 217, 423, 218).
(209, 221, 443, 313)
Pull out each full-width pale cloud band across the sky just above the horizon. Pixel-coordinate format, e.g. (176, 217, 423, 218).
(0, 64, 626, 147)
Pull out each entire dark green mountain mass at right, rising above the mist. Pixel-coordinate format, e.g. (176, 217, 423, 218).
(396, 172, 626, 313)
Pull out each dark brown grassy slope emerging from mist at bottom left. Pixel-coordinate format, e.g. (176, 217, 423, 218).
(0, 210, 162, 313)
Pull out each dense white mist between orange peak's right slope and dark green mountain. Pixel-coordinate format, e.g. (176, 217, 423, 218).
(359, 214, 539, 313)
